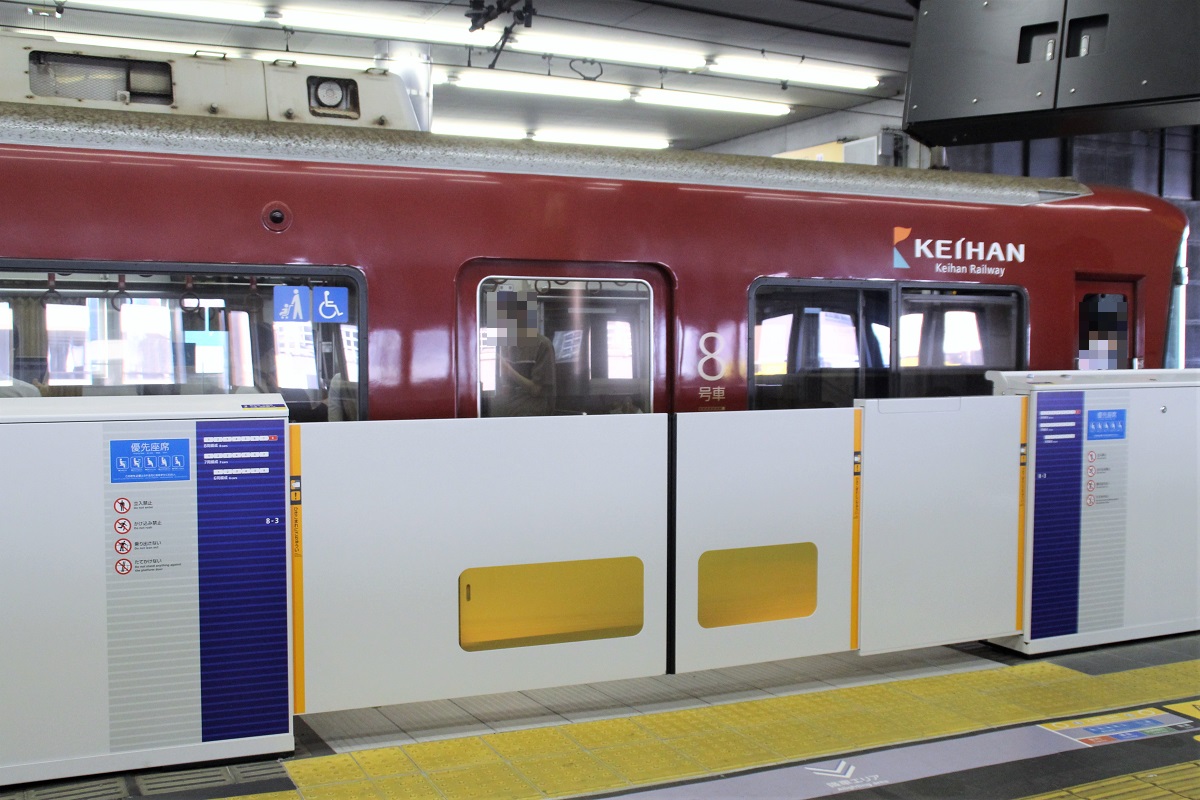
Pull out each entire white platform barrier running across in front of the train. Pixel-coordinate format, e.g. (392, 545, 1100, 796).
(11, 381, 1200, 784)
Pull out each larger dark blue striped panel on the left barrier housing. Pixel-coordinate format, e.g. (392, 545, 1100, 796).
(196, 420, 290, 741)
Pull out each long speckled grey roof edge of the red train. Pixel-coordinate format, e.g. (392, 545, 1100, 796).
(0, 103, 1091, 206)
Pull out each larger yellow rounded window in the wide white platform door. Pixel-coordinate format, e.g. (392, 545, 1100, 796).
(458, 557, 644, 651)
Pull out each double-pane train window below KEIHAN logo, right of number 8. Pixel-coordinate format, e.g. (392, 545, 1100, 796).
(750, 278, 1025, 409)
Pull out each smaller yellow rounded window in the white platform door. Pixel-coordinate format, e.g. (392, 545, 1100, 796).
(697, 542, 817, 627)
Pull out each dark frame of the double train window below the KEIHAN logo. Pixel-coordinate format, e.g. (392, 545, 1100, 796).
(746, 277, 1030, 409)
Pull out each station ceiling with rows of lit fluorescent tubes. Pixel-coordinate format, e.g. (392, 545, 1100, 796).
(0, 0, 914, 149)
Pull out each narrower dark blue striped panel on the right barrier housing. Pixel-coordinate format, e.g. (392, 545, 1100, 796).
(1030, 392, 1085, 639)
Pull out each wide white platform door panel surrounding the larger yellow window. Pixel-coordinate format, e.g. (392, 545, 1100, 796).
(291, 415, 667, 712)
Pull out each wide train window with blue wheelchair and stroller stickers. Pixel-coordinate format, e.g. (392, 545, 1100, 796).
(0, 271, 362, 421)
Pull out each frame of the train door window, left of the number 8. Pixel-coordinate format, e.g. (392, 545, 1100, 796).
(472, 272, 655, 419)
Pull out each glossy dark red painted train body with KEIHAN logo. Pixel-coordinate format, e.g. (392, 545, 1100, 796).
(0, 145, 1186, 419)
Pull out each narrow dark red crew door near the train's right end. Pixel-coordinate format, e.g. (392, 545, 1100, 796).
(1075, 279, 1138, 369)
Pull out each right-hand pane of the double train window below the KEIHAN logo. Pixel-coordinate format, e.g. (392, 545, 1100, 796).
(899, 287, 1022, 397)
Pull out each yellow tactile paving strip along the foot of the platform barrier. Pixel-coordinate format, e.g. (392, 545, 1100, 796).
(220, 660, 1200, 800)
